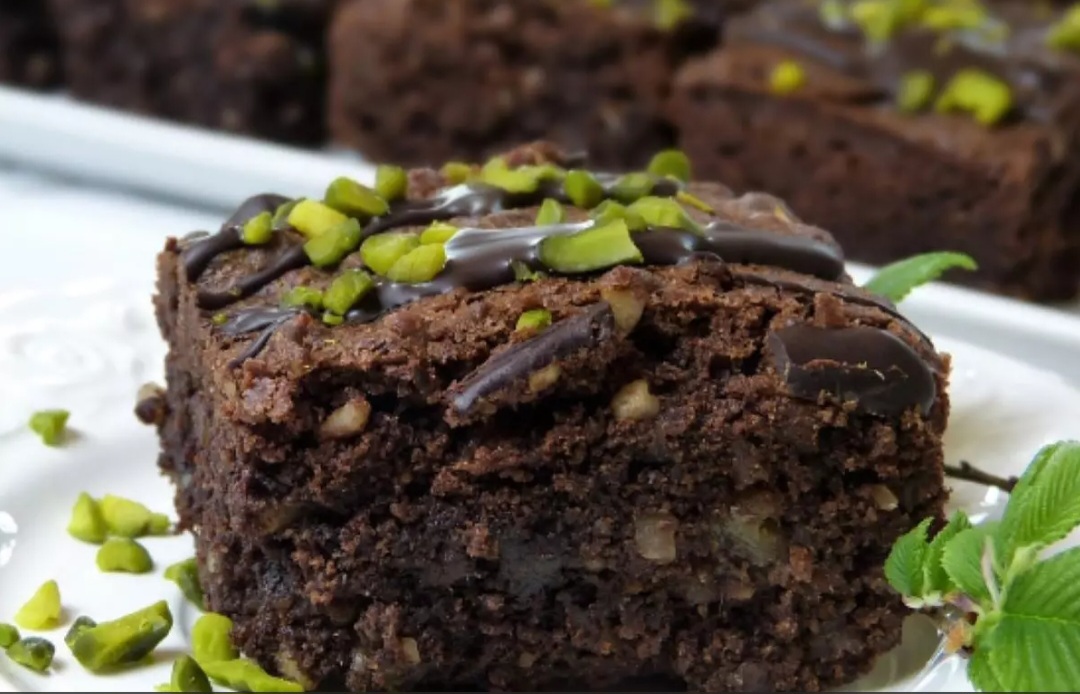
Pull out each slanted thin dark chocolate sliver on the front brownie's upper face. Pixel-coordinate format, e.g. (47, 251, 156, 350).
(449, 301, 615, 413)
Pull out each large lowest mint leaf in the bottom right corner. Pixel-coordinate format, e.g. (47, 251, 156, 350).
(974, 548, 1080, 692)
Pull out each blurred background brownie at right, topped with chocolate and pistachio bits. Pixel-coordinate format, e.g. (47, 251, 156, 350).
(671, 1, 1080, 301)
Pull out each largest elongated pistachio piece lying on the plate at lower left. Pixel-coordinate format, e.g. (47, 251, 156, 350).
(71, 600, 173, 672)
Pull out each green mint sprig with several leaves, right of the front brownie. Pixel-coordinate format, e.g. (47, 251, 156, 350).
(885, 440, 1080, 692)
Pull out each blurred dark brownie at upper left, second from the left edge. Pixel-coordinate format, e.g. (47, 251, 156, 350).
(50, 0, 334, 145)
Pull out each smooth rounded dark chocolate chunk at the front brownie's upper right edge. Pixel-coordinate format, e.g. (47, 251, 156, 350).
(767, 325, 937, 416)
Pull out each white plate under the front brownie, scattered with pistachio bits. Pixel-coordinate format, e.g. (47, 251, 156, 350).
(0, 283, 1080, 692)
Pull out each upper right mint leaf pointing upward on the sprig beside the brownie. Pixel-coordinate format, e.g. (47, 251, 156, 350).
(998, 441, 1080, 568)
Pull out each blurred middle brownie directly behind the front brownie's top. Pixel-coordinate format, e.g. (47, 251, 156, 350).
(328, 0, 726, 171)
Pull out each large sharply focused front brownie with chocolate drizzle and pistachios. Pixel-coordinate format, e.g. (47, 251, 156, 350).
(150, 144, 948, 692)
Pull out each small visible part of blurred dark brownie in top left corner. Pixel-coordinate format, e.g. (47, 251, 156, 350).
(0, 0, 60, 89)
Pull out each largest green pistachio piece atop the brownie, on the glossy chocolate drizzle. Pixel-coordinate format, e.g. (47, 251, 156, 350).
(540, 219, 645, 274)
